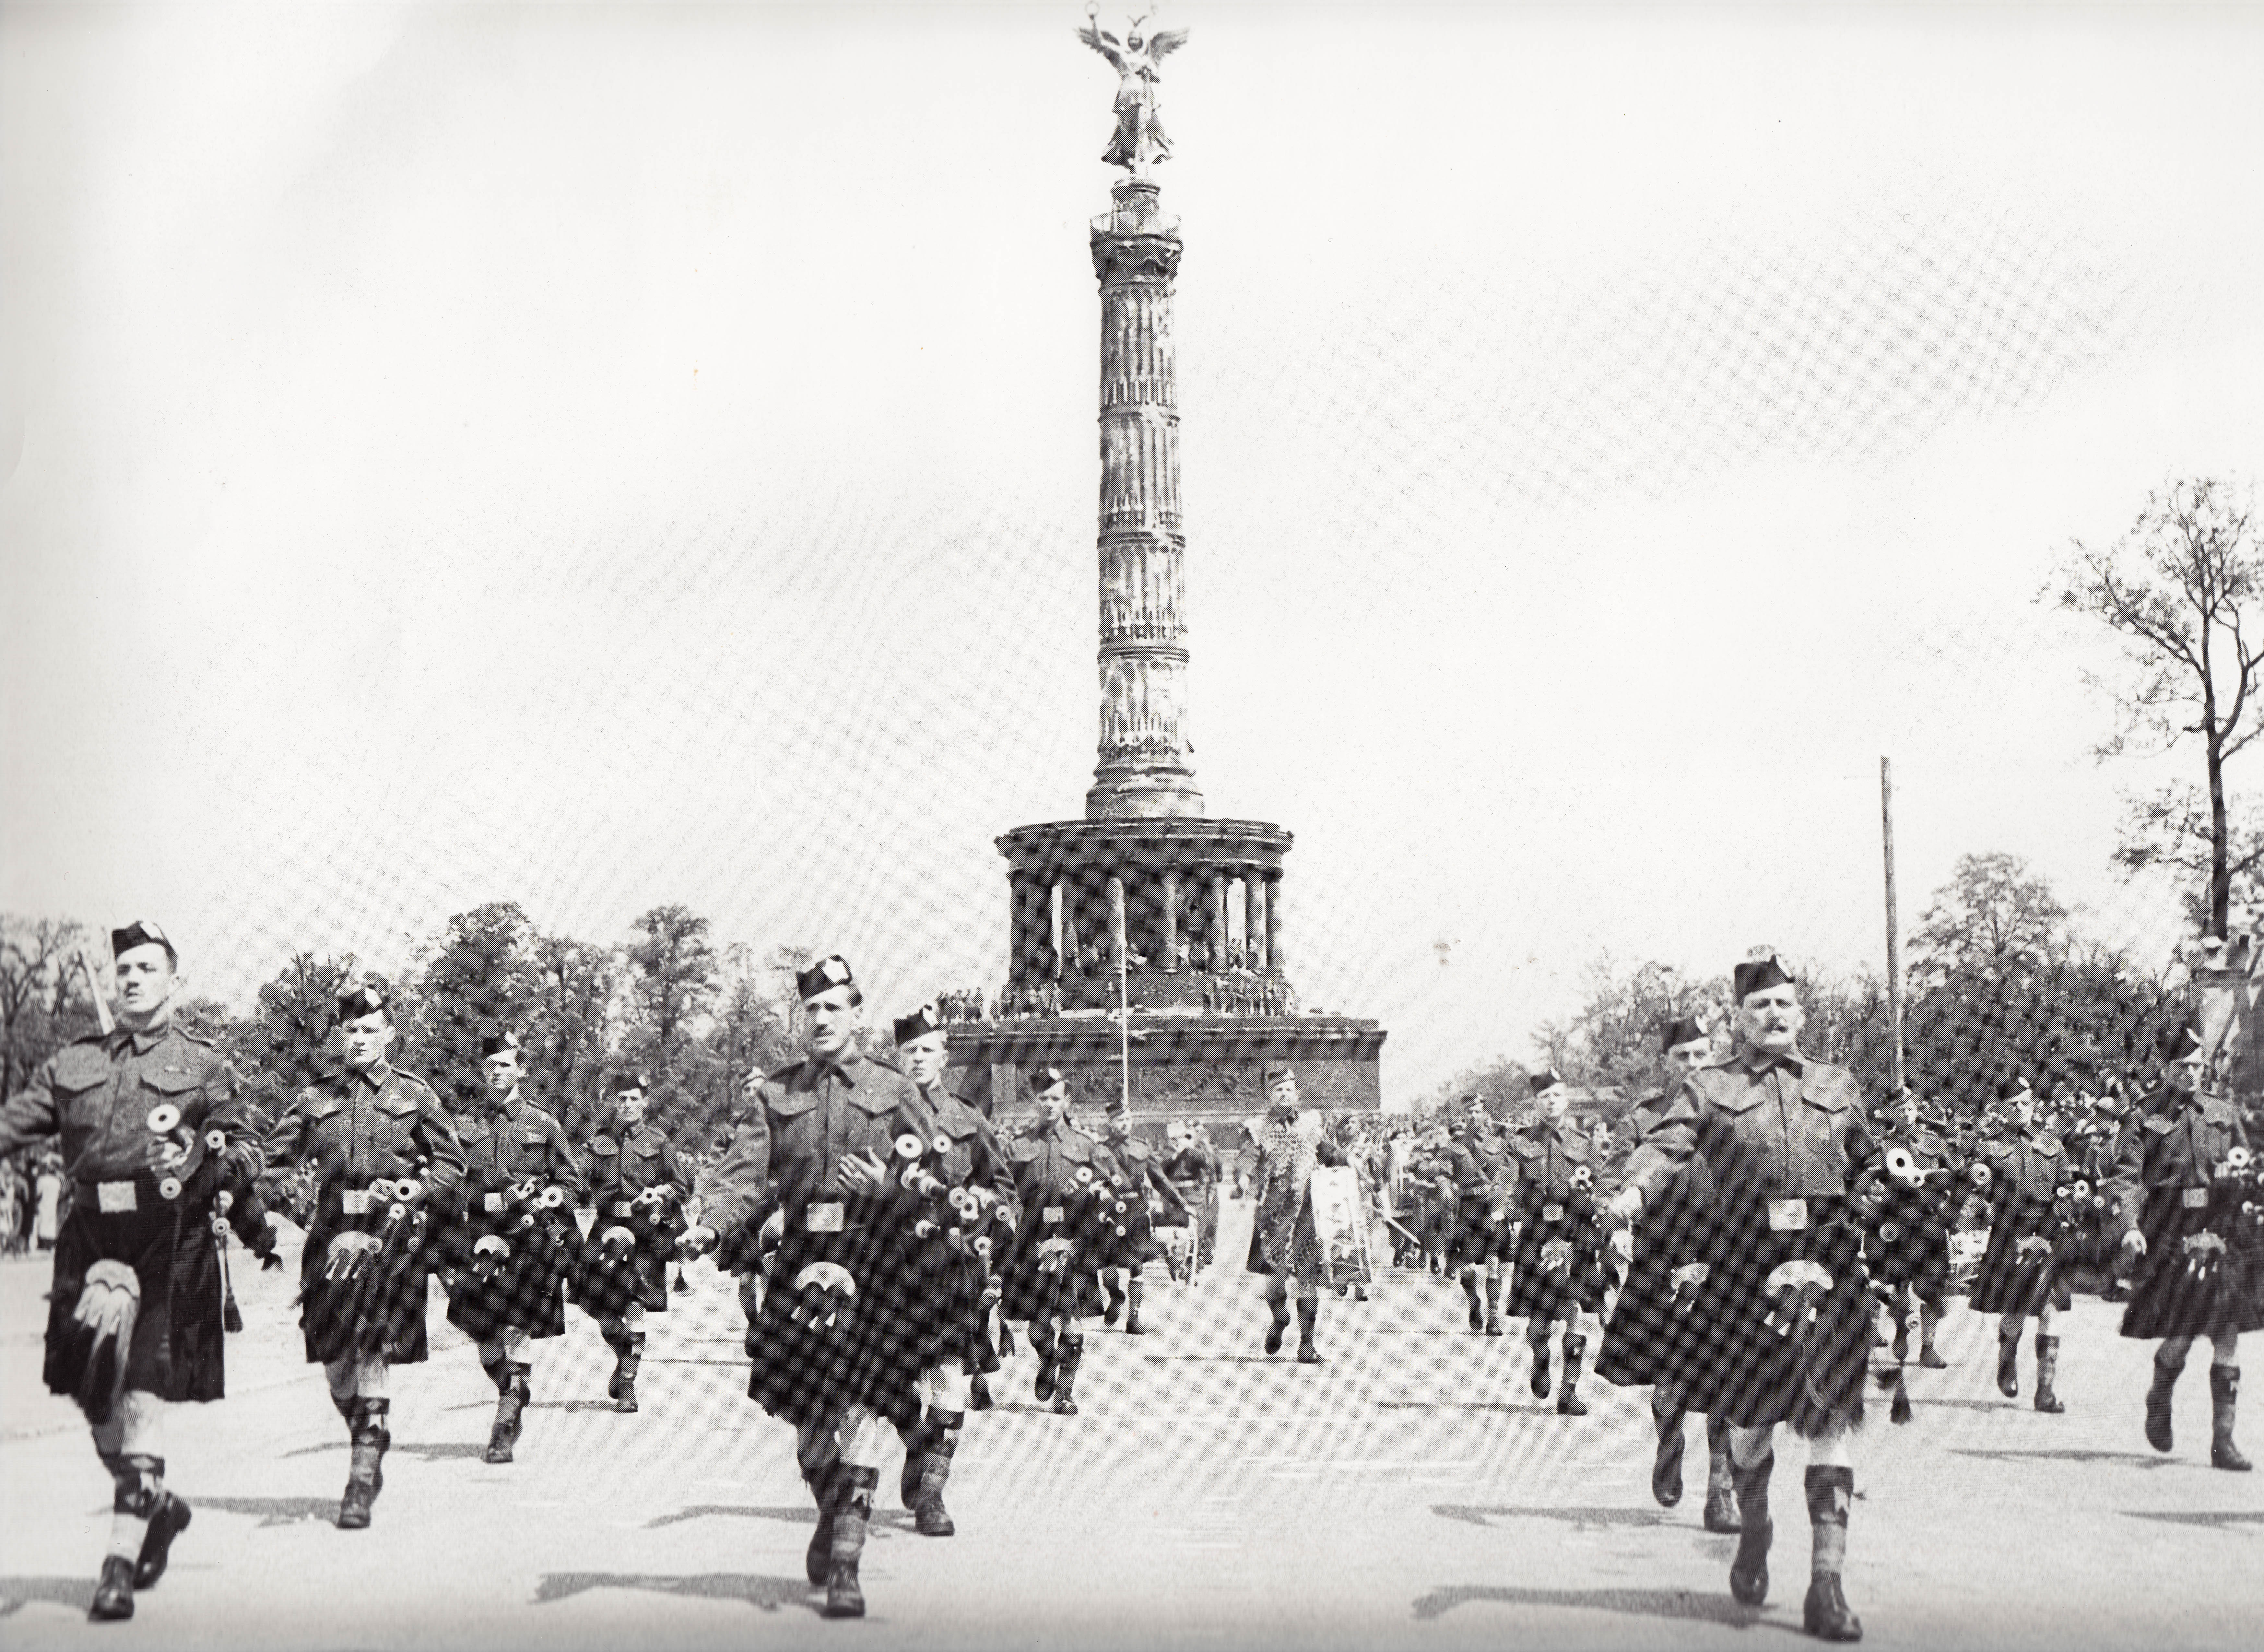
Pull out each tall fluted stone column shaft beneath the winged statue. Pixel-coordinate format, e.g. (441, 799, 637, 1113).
(1084, 179, 1202, 819)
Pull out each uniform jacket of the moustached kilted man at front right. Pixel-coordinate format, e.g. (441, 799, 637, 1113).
(1626, 1050, 1879, 1218)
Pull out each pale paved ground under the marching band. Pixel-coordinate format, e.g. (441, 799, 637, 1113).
(0, 1206, 2264, 1652)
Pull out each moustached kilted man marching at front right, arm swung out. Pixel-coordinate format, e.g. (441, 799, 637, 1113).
(1612, 957, 1881, 1641)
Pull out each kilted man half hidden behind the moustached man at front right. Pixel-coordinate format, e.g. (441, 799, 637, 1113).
(1596, 1016, 1737, 1532)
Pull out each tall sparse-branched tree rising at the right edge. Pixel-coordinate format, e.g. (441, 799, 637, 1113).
(2040, 478, 2264, 935)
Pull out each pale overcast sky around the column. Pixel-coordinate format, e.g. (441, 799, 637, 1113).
(0, 0, 2264, 1098)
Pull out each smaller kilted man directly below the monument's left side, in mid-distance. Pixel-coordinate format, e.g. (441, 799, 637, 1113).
(1005, 1066, 1098, 1417)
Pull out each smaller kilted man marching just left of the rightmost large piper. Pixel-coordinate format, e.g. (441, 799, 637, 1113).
(1972, 1080, 2074, 1412)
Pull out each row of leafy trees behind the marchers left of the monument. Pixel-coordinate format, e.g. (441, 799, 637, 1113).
(0, 901, 855, 1150)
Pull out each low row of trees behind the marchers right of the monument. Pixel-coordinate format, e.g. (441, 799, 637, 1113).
(1433, 856, 2194, 1114)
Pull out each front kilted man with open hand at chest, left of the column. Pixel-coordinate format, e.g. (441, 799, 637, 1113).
(684, 953, 926, 1618)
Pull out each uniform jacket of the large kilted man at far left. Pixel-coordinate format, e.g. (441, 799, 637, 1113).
(0, 1021, 260, 1181)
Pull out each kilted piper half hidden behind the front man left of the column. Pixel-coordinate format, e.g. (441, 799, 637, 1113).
(897, 1005, 1017, 1537)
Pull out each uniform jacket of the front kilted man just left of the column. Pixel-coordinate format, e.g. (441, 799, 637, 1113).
(700, 1043, 928, 1233)
